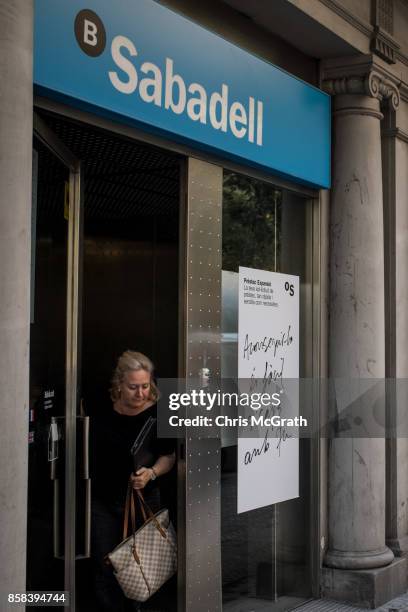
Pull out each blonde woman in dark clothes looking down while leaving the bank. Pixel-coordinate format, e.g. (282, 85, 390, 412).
(91, 351, 175, 612)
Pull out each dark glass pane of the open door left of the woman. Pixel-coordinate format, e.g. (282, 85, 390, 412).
(27, 140, 69, 590)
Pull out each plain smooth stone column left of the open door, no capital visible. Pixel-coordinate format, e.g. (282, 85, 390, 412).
(0, 0, 33, 610)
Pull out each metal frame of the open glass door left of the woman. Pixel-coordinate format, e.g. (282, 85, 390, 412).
(33, 111, 82, 611)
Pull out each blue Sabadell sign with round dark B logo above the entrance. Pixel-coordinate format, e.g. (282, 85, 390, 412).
(34, 0, 330, 188)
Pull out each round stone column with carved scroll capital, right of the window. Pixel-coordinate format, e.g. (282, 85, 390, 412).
(323, 59, 399, 605)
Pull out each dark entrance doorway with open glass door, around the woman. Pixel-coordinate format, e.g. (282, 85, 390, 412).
(27, 113, 183, 611)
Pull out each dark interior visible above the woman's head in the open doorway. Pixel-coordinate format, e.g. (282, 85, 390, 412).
(46, 116, 180, 390)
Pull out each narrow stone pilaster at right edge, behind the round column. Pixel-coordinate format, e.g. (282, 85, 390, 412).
(382, 104, 408, 556)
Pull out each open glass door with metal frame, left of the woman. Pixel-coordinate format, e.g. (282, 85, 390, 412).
(27, 115, 82, 609)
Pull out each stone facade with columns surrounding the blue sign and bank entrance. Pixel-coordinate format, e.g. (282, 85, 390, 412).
(0, 0, 408, 609)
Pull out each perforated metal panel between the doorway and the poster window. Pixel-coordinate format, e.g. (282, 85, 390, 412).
(185, 159, 222, 612)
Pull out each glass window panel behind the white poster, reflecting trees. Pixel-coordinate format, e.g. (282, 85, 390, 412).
(221, 172, 312, 612)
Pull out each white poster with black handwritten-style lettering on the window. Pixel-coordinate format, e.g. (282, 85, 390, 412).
(238, 267, 299, 512)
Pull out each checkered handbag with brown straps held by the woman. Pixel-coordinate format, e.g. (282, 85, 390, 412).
(108, 484, 177, 602)
